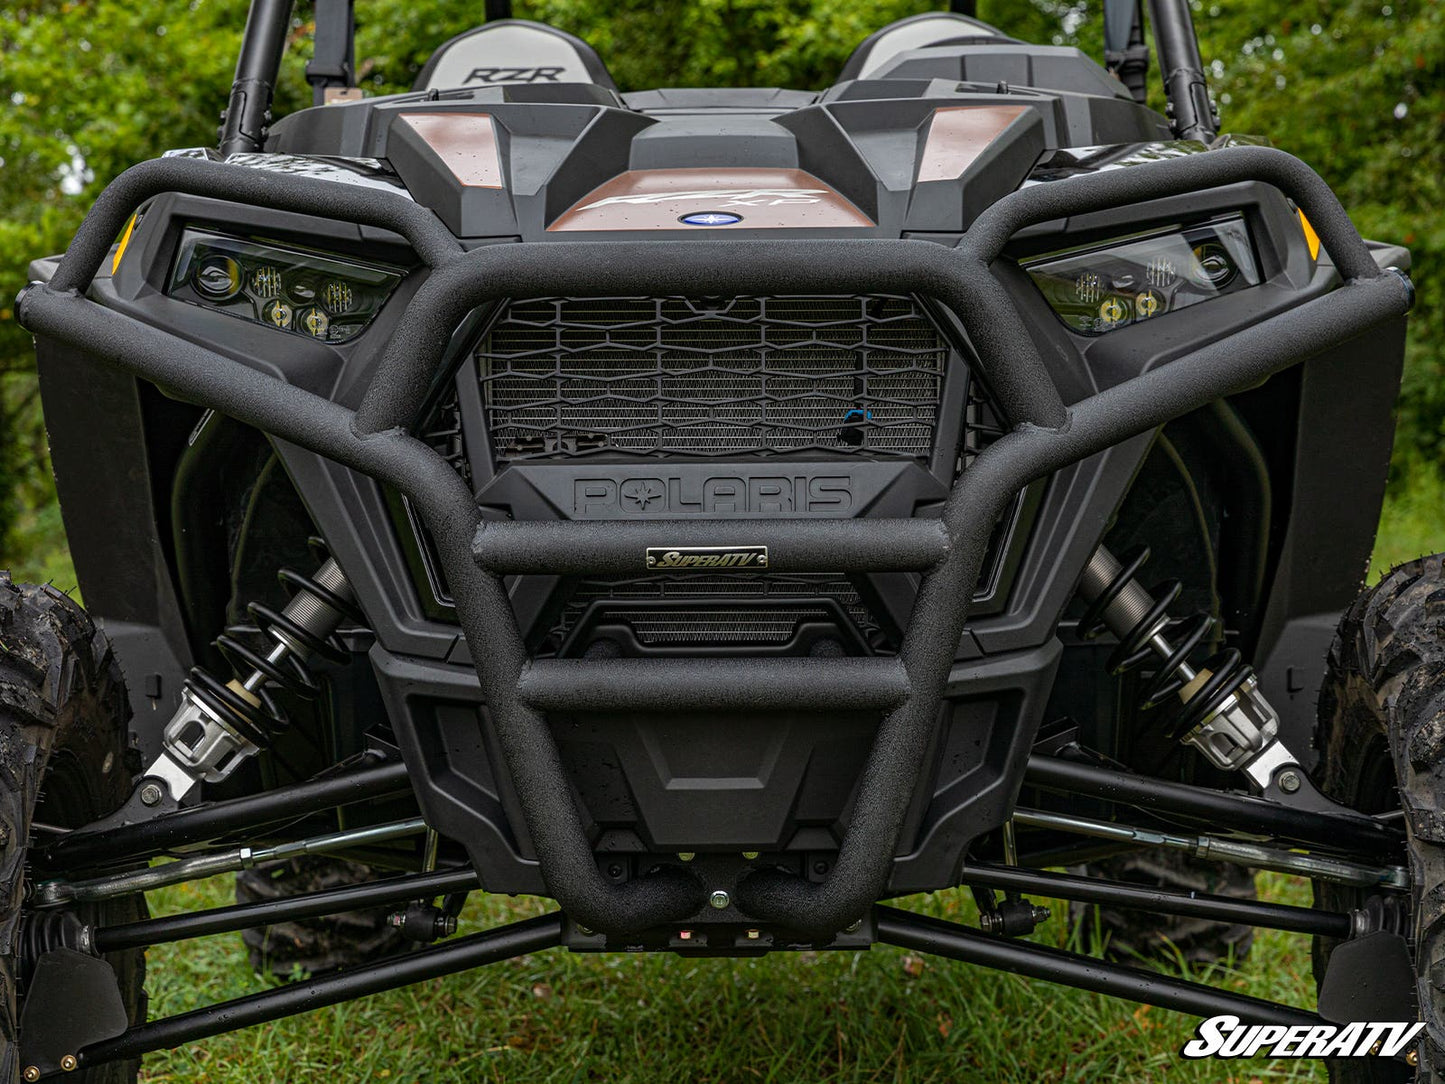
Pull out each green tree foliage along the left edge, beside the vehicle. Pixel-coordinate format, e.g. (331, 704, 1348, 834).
(0, 0, 306, 554)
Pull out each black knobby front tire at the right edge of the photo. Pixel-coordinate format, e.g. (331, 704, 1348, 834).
(1314, 555, 1445, 1084)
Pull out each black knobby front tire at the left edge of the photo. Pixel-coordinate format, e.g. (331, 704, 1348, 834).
(0, 572, 146, 1084)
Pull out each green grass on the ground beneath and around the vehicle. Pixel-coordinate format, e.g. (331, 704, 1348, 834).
(2, 456, 1445, 1084)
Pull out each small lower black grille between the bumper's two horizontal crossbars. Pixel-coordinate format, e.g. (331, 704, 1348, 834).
(548, 572, 881, 650)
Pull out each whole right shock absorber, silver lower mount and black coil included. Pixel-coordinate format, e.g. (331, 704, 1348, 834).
(1079, 546, 1305, 793)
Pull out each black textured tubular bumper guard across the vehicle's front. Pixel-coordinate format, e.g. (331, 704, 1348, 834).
(16, 147, 1412, 938)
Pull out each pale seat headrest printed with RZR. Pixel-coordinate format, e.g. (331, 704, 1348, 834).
(415, 19, 617, 91)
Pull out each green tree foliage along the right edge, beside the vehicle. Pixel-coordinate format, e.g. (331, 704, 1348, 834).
(1196, 0, 1445, 484)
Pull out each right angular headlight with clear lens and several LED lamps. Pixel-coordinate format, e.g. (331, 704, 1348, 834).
(1026, 215, 1260, 334)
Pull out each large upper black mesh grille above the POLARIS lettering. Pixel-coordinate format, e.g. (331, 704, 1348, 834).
(478, 295, 948, 461)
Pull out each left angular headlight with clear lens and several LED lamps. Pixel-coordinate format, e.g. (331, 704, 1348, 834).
(166, 230, 402, 343)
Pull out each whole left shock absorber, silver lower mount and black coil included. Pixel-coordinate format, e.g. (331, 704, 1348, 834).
(139, 552, 364, 805)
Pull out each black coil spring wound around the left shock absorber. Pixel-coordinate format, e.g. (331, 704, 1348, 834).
(186, 538, 366, 749)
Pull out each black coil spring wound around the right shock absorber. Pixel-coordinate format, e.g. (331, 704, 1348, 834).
(1078, 546, 1254, 737)
